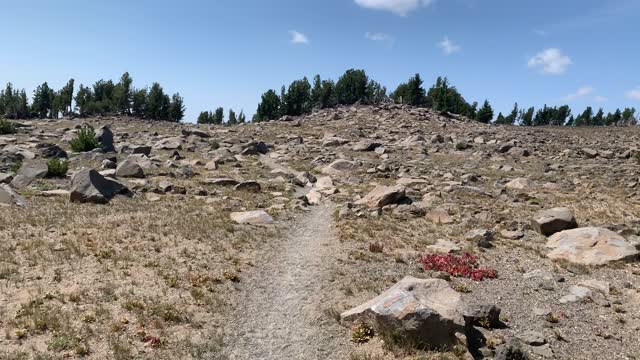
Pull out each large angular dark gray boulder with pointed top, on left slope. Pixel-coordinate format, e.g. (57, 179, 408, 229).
(69, 170, 133, 204)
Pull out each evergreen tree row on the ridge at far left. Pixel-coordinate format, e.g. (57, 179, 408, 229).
(0, 73, 185, 122)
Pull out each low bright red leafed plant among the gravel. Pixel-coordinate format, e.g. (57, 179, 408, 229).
(420, 253, 498, 281)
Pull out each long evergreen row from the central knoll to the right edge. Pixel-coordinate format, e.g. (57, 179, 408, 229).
(253, 69, 637, 126)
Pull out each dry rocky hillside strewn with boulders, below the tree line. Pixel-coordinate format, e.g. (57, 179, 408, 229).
(0, 105, 640, 359)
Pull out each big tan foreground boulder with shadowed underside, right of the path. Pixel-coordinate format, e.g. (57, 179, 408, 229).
(340, 276, 464, 347)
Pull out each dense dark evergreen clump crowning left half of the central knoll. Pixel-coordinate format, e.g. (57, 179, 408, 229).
(253, 69, 388, 122)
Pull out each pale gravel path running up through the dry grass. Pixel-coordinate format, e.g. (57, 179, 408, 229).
(225, 206, 351, 360)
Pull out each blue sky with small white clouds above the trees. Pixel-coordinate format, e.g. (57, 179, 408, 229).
(0, 0, 640, 120)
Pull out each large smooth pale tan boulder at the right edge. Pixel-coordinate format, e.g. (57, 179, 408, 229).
(546, 227, 638, 265)
